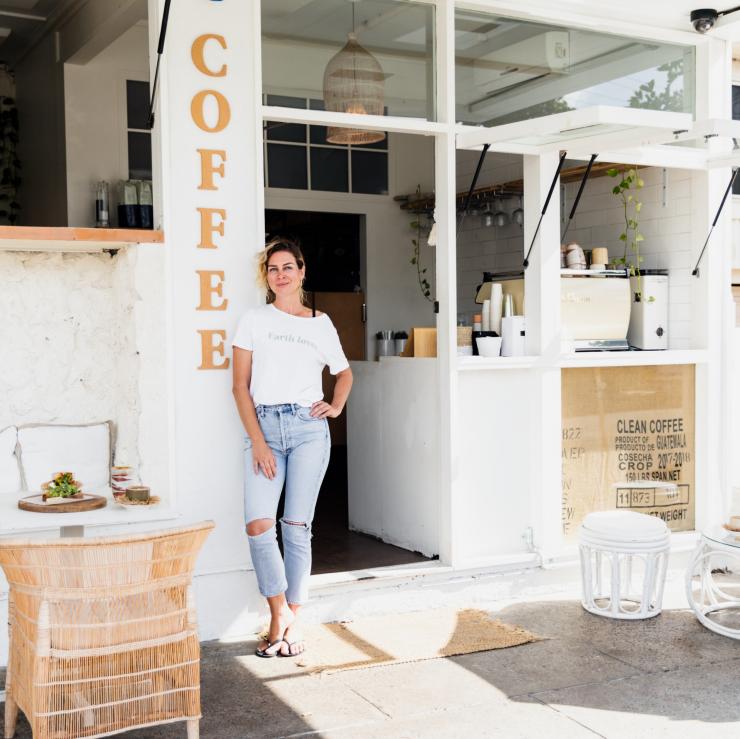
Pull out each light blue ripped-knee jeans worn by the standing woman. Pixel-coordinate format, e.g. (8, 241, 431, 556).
(244, 403, 331, 604)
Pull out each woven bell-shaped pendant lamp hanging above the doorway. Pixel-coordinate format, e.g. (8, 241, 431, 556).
(324, 29, 385, 146)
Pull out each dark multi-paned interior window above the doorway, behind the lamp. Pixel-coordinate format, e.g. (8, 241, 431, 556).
(264, 95, 388, 195)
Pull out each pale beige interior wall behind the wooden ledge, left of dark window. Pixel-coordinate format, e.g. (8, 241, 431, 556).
(64, 24, 149, 226)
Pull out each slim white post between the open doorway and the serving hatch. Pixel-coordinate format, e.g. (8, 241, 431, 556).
(434, 0, 456, 565)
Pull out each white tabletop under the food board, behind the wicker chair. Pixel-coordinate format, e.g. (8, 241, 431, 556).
(0, 490, 179, 537)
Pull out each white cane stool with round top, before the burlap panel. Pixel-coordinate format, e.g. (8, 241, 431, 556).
(580, 511, 671, 619)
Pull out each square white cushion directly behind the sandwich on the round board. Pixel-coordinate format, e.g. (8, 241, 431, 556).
(18, 422, 111, 492)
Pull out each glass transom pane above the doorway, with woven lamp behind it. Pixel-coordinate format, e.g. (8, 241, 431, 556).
(261, 0, 435, 120)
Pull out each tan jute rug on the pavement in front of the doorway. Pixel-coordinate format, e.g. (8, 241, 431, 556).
(296, 608, 540, 673)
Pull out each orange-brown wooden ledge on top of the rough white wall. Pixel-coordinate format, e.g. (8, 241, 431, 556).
(0, 226, 164, 252)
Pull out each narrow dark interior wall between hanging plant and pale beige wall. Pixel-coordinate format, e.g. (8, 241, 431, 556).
(15, 34, 67, 226)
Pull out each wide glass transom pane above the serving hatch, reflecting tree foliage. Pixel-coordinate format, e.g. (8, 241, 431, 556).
(455, 9, 694, 126)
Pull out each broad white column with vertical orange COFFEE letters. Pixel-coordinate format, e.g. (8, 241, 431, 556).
(149, 0, 264, 638)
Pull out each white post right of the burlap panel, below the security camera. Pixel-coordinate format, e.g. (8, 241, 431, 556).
(690, 38, 736, 530)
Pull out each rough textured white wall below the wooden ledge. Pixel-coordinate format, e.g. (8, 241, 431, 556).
(0, 249, 140, 465)
